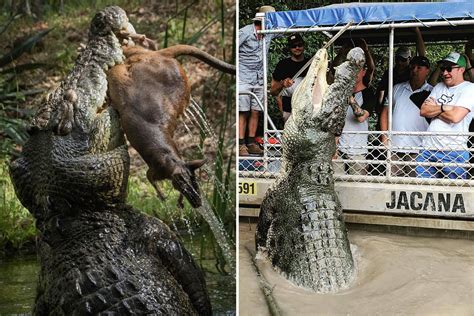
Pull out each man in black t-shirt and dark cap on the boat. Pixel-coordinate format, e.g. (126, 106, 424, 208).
(270, 34, 309, 122)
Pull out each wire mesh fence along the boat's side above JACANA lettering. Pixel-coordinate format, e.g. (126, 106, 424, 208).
(239, 130, 474, 187)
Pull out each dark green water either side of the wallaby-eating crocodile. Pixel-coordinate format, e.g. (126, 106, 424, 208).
(0, 236, 236, 315)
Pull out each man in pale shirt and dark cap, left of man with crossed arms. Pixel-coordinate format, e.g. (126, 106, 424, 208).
(380, 56, 433, 177)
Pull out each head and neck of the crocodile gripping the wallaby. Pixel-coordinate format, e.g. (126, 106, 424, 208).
(10, 7, 135, 218)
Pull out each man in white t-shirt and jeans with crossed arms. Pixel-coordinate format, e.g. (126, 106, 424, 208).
(416, 52, 474, 179)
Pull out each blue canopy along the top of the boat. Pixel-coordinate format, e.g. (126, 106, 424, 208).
(265, 1, 474, 29)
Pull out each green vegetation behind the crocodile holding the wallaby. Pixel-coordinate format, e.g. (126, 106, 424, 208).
(0, 0, 235, 265)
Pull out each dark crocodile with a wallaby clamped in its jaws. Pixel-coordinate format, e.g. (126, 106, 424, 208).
(10, 6, 212, 315)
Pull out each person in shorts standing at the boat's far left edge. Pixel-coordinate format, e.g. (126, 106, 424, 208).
(239, 6, 275, 156)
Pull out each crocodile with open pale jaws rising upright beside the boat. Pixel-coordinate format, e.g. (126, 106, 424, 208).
(255, 48, 365, 293)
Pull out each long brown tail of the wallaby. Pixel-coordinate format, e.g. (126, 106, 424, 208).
(159, 45, 236, 75)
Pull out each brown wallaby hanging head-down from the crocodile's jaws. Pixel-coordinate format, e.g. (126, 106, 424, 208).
(107, 45, 235, 208)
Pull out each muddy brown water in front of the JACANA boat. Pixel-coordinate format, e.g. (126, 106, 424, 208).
(239, 223, 474, 315)
